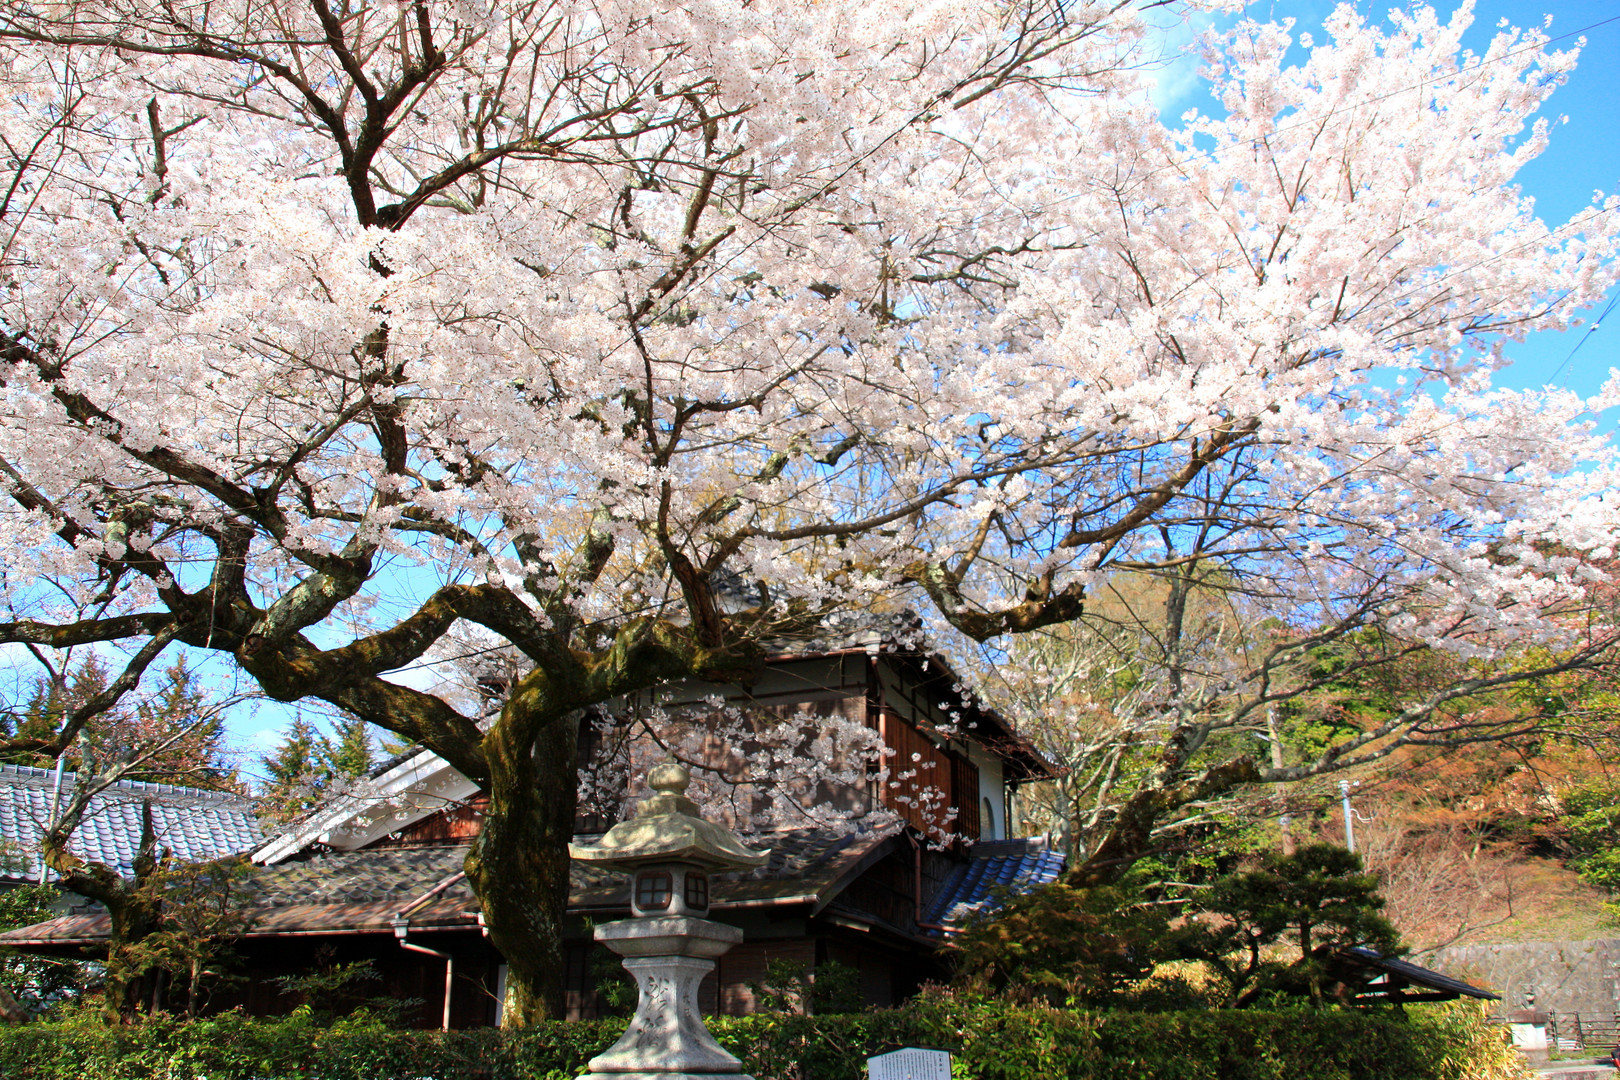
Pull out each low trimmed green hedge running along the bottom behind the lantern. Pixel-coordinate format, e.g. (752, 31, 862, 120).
(0, 1001, 1520, 1080)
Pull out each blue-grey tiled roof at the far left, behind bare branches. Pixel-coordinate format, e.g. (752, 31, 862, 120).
(0, 764, 264, 881)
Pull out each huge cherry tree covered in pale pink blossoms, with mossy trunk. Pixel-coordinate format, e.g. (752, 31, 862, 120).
(0, 0, 1620, 1023)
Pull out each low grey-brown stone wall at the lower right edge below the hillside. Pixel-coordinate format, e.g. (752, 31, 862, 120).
(1414, 938, 1620, 1017)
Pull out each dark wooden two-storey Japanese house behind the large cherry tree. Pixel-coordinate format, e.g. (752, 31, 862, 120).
(0, 630, 1061, 1028)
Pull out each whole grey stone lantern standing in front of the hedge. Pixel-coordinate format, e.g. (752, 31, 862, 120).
(569, 761, 770, 1080)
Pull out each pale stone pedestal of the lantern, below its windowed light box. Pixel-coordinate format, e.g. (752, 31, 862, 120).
(582, 915, 752, 1080)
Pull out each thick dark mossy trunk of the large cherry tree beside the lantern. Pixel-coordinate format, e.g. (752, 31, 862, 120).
(465, 712, 578, 1028)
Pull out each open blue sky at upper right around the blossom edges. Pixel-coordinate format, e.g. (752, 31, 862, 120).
(1158, 0, 1620, 396)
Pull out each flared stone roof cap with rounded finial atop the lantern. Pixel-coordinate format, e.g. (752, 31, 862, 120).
(569, 761, 770, 873)
